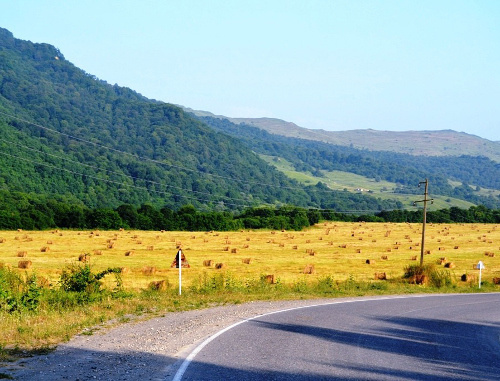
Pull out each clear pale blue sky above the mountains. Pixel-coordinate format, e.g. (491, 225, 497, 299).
(0, 0, 500, 141)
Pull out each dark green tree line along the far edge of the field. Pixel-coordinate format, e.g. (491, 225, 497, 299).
(0, 191, 500, 231)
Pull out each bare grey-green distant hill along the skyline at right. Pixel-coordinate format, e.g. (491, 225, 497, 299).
(183, 109, 500, 163)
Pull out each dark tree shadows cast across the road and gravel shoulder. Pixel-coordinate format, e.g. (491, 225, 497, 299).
(1, 310, 500, 381)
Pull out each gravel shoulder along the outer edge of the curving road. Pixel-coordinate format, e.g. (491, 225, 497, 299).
(0, 299, 338, 381)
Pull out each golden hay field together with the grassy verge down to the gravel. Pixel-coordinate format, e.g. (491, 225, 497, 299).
(0, 222, 500, 353)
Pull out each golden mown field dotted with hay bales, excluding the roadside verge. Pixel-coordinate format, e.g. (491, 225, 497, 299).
(0, 222, 500, 289)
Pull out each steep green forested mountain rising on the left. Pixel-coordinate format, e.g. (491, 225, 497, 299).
(0, 28, 401, 214)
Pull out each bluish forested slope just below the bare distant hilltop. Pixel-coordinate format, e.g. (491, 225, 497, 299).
(198, 116, 500, 208)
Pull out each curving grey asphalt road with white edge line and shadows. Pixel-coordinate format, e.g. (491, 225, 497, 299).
(174, 293, 500, 381)
